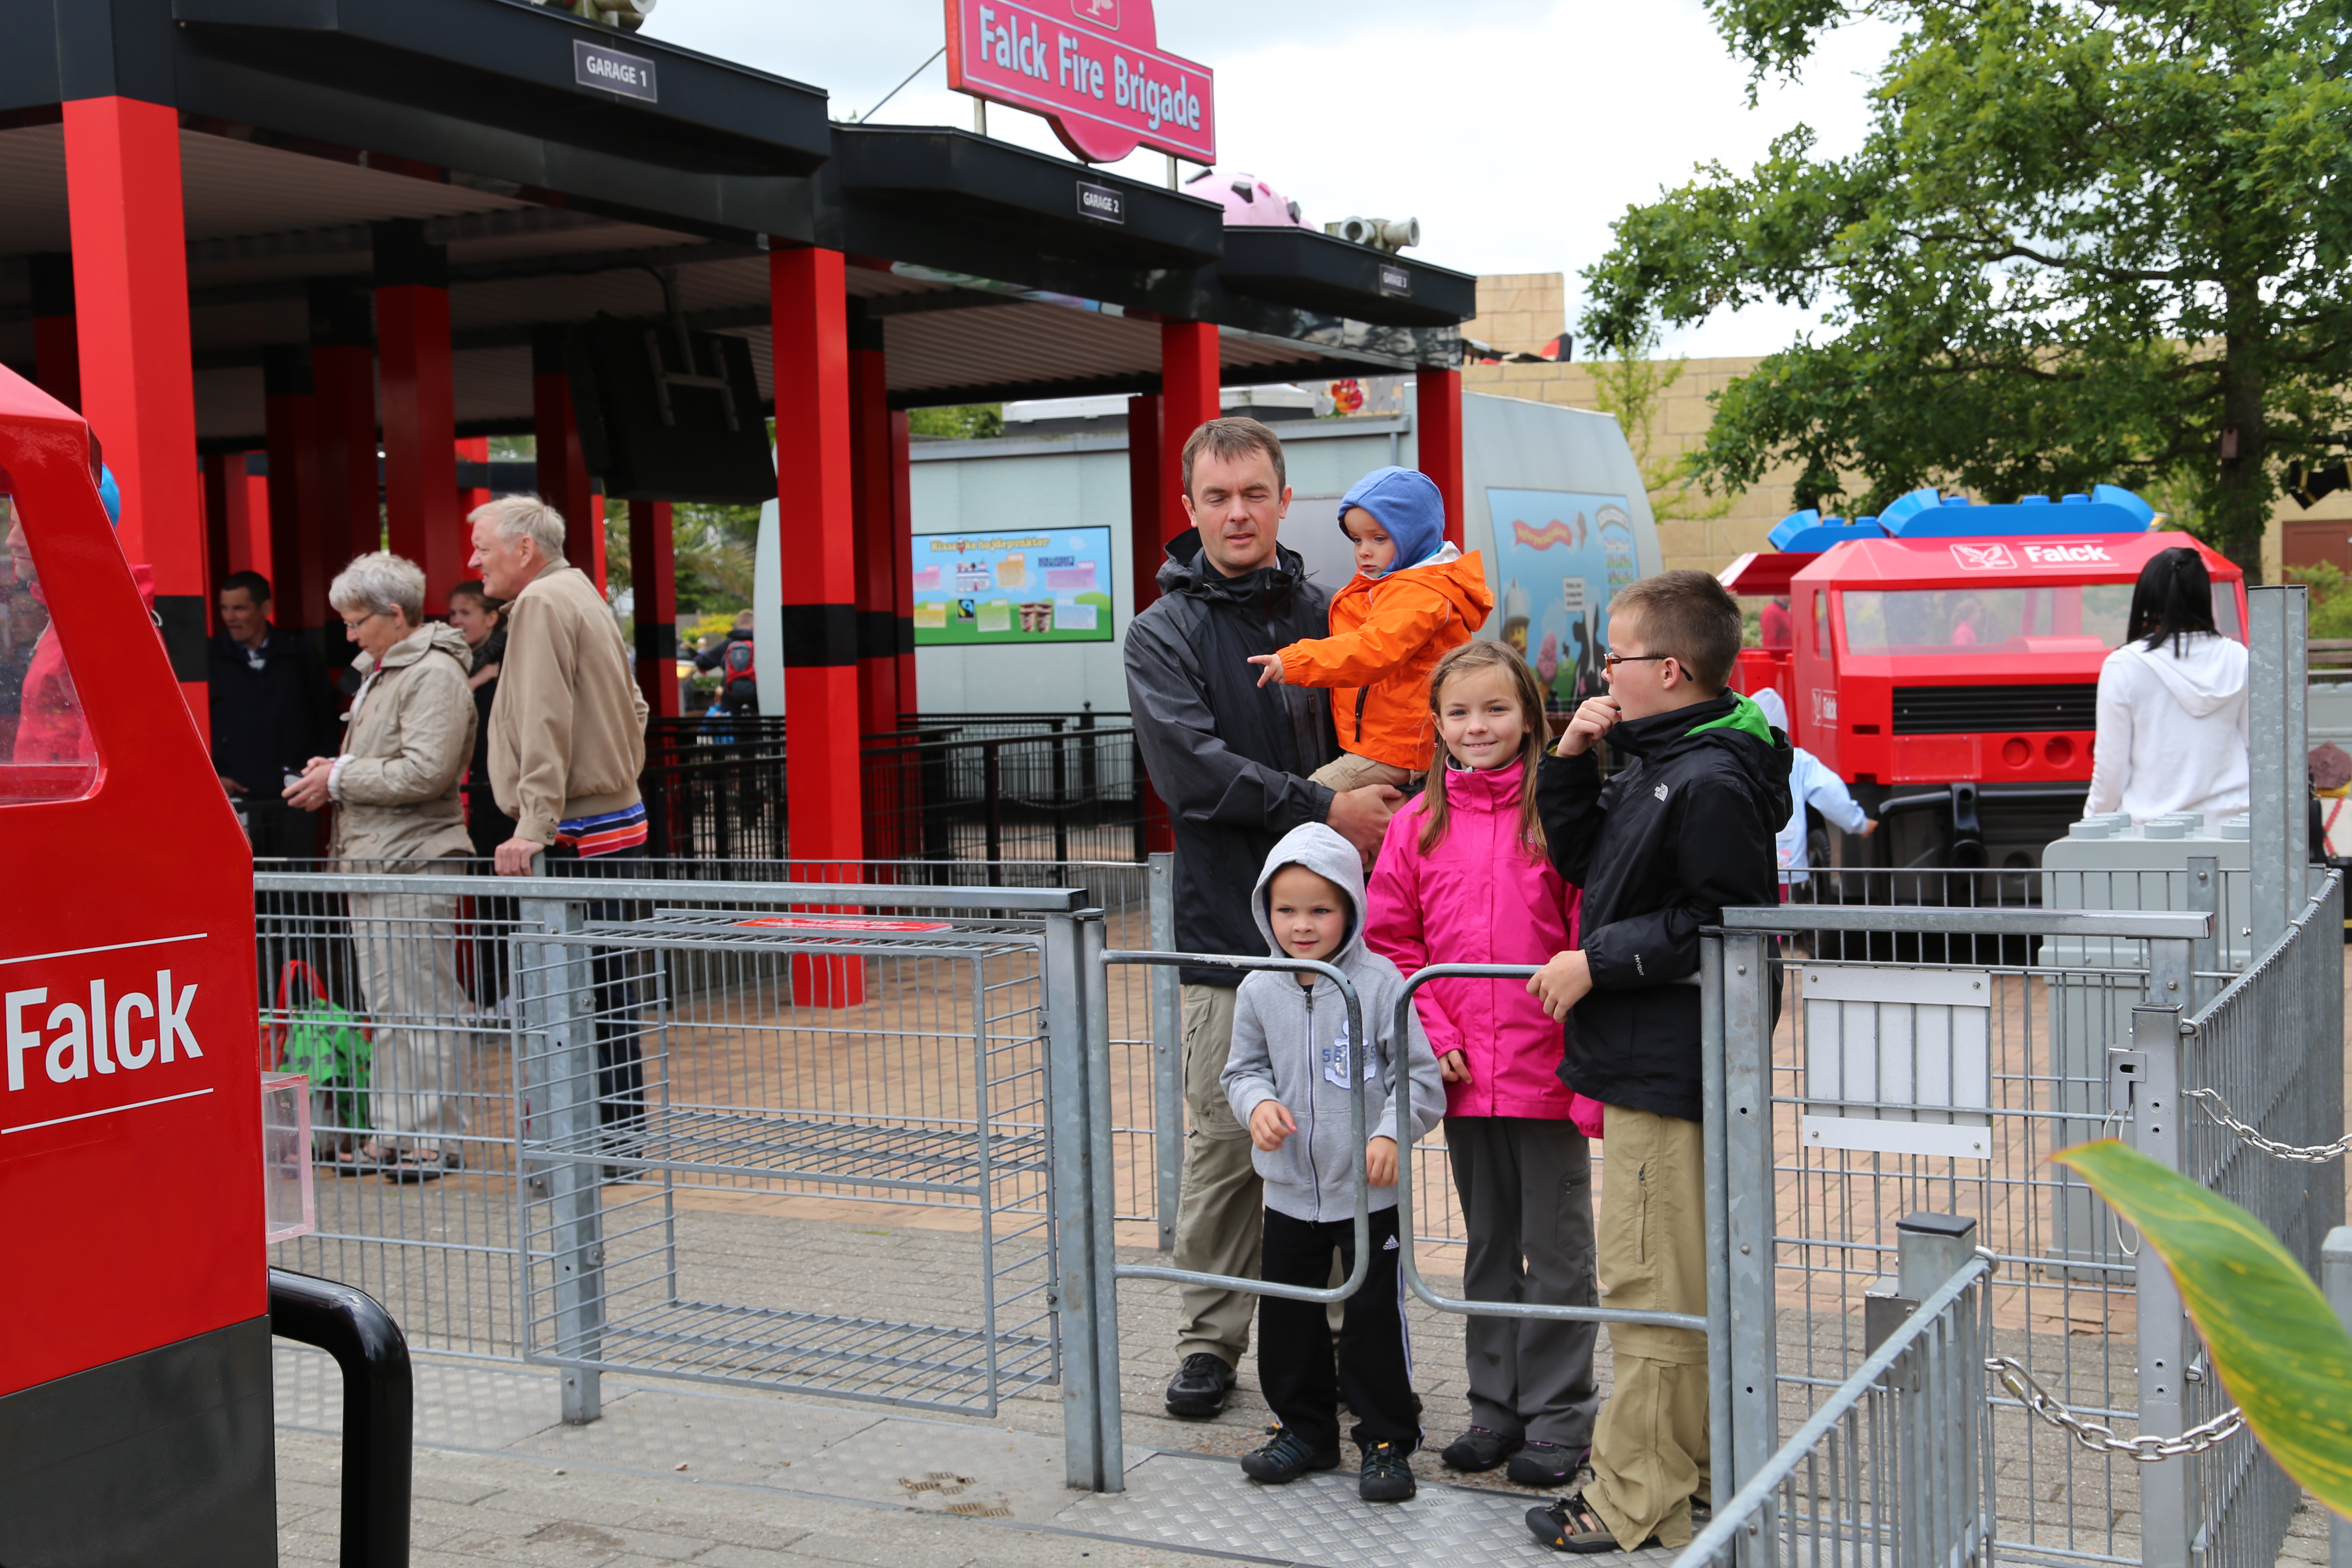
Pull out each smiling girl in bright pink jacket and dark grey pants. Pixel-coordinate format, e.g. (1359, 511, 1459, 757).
(1364, 642, 1599, 1486)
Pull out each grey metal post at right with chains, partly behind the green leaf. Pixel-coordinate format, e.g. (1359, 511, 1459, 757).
(2131, 1006, 2199, 1568)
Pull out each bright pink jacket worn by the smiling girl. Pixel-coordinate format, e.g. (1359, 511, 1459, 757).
(1364, 764, 1599, 1131)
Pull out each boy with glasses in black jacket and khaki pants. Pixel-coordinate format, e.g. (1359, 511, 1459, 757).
(1526, 571, 1790, 1552)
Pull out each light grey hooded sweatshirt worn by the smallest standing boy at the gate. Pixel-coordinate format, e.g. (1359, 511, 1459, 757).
(1223, 823, 1446, 1222)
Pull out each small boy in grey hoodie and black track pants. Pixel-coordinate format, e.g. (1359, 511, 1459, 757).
(1223, 823, 1446, 1502)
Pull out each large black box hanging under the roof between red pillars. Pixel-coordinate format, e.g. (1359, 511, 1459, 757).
(564, 315, 776, 503)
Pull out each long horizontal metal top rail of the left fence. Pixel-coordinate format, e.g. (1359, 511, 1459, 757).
(254, 870, 1087, 912)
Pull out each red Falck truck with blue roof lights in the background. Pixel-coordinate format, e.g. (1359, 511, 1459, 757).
(1722, 484, 2246, 884)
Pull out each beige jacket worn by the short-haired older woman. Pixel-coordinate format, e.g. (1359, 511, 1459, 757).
(334, 623, 475, 861)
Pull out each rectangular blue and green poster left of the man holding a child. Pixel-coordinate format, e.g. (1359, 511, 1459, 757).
(915, 529, 1110, 649)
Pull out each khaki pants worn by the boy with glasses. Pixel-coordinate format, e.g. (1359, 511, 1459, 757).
(1585, 1105, 1712, 1552)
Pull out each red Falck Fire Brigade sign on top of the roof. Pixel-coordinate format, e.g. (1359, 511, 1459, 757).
(948, 0, 1216, 165)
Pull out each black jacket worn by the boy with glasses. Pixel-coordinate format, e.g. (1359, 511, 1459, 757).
(1536, 691, 1790, 1121)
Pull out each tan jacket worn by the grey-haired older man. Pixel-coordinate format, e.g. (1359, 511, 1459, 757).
(489, 567, 644, 844)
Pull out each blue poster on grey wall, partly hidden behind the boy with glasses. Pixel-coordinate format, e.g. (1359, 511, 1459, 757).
(1486, 489, 1642, 710)
